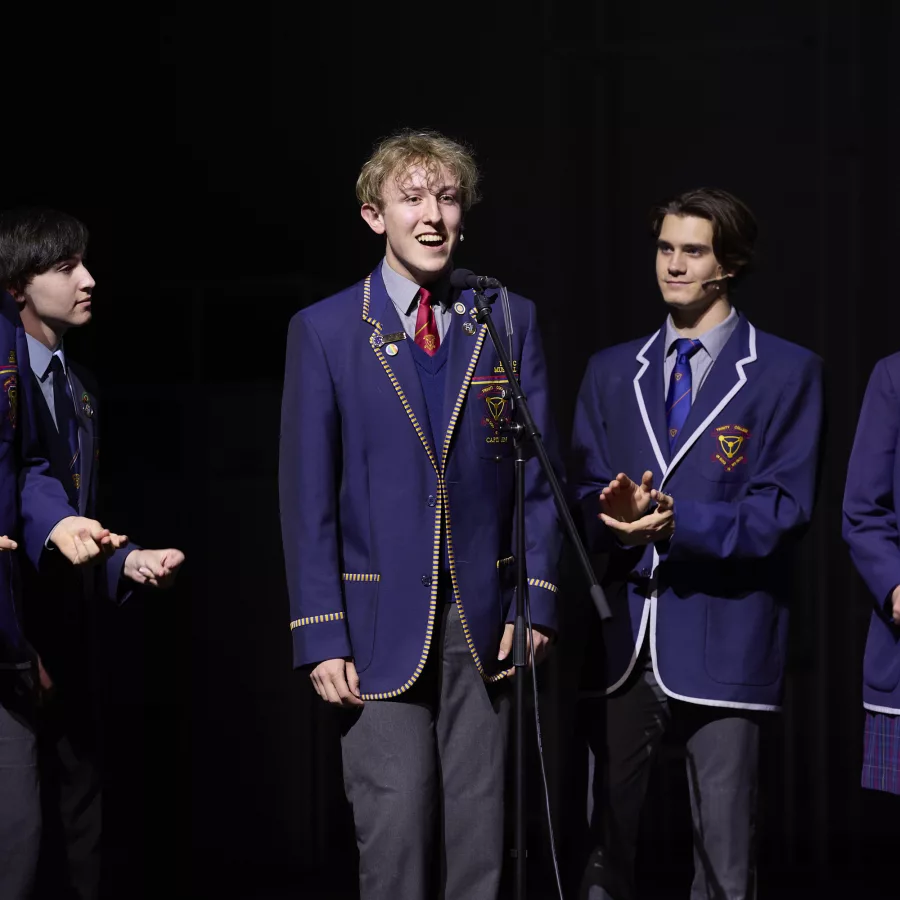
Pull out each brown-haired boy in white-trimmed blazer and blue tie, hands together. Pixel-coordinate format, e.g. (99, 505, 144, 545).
(573, 188, 822, 900)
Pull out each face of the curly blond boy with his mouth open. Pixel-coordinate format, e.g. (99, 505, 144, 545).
(361, 166, 462, 285)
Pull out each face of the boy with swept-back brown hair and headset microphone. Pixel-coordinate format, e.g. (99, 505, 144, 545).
(656, 215, 727, 310)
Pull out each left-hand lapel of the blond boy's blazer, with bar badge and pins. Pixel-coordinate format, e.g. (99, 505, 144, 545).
(363, 266, 440, 471)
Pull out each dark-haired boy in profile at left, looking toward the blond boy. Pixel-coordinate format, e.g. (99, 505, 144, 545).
(0, 209, 184, 900)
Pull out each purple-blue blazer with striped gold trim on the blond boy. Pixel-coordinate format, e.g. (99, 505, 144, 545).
(279, 270, 559, 699)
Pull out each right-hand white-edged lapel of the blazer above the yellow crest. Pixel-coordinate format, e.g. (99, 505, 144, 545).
(669, 316, 756, 486)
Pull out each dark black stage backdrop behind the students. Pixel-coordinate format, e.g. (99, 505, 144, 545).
(14, 0, 900, 898)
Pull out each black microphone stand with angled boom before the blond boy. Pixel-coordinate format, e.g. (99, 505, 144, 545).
(474, 289, 612, 900)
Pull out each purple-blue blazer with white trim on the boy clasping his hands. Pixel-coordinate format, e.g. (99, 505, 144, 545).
(573, 316, 823, 710)
